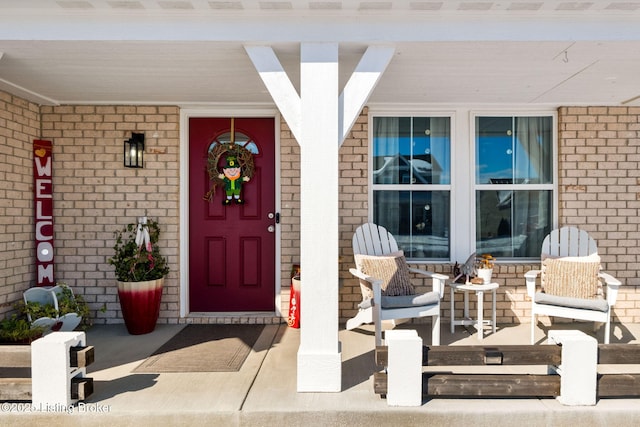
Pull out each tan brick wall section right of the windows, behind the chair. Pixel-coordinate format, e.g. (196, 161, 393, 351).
(558, 107, 640, 322)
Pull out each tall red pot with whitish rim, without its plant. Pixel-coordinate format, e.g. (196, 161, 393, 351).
(118, 278, 164, 335)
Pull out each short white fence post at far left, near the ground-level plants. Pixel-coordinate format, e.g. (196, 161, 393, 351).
(31, 332, 87, 412)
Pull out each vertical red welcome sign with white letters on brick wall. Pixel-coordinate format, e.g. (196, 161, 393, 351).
(33, 139, 55, 286)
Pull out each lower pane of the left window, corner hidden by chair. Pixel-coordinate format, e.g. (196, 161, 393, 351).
(373, 191, 450, 259)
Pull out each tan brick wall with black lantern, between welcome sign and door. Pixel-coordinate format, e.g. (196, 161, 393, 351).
(41, 106, 180, 323)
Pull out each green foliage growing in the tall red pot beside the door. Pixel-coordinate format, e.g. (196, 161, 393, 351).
(107, 219, 169, 282)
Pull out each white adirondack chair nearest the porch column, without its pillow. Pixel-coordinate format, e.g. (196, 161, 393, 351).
(346, 223, 449, 346)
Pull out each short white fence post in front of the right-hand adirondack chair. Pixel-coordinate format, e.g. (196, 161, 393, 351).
(548, 330, 598, 406)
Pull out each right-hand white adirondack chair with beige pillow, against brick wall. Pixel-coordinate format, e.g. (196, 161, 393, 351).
(525, 227, 621, 344)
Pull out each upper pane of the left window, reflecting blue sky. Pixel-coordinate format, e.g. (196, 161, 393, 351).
(372, 117, 451, 184)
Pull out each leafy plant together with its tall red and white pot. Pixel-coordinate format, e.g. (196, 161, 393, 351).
(107, 217, 169, 335)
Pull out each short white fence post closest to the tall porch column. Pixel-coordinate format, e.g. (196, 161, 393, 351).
(385, 329, 422, 406)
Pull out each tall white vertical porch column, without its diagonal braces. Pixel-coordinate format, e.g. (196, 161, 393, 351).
(298, 43, 342, 391)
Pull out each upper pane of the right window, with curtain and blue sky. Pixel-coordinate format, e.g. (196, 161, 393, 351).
(476, 117, 553, 184)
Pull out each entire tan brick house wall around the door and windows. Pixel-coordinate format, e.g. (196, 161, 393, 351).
(0, 92, 640, 324)
